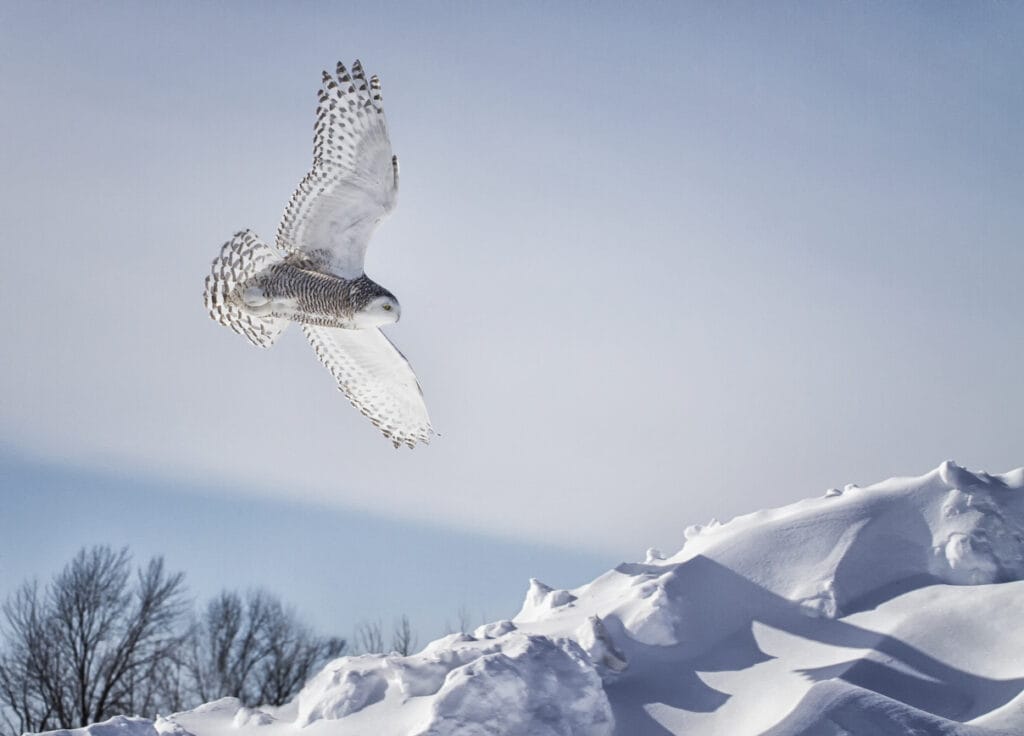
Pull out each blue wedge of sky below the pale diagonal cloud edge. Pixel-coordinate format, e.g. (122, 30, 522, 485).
(0, 454, 602, 644)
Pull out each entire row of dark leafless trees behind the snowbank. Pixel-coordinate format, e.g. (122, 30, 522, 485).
(0, 547, 416, 736)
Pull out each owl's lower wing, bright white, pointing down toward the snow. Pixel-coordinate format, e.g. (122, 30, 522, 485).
(302, 324, 434, 447)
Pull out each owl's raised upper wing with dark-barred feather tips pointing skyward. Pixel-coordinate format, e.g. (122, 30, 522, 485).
(278, 60, 398, 278)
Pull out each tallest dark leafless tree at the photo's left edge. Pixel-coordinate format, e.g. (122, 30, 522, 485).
(0, 547, 185, 731)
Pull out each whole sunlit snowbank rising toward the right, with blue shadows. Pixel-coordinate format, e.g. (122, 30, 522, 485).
(37, 462, 1024, 736)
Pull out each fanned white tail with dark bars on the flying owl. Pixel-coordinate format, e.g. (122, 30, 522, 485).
(203, 230, 288, 348)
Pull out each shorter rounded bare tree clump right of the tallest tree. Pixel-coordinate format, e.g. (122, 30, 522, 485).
(187, 591, 345, 705)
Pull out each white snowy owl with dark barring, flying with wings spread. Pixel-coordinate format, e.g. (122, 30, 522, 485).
(203, 61, 434, 447)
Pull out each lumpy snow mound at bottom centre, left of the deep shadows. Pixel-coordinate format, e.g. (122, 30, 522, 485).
(288, 621, 612, 736)
